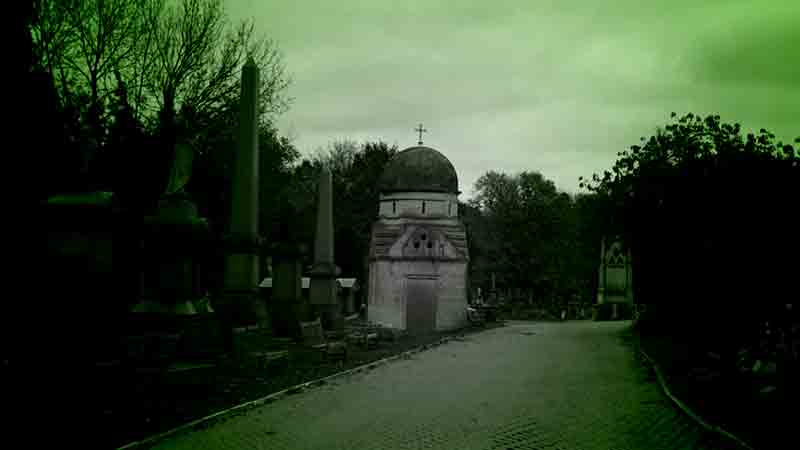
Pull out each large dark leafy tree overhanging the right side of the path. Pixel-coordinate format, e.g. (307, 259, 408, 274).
(584, 113, 800, 350)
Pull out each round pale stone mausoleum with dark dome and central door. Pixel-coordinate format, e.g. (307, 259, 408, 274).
(367, 146, 469, 333)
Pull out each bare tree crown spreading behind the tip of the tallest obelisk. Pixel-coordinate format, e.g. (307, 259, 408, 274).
(147, 0, 289, 132)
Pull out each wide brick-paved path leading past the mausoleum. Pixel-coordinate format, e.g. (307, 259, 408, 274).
(148, 321, 744, 450)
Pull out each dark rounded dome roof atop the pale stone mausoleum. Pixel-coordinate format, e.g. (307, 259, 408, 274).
(378, 146, 458, 194)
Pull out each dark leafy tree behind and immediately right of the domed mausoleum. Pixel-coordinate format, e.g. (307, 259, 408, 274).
(462, 172, 587, 301)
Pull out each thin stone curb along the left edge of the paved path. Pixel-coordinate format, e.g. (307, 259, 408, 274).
(117, 330, 478, 450)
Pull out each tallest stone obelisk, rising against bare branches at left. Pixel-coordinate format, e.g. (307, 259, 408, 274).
(221, 58, 266, 350)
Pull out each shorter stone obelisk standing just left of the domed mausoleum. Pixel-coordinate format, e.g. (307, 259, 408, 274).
(309, 168, 344, 330)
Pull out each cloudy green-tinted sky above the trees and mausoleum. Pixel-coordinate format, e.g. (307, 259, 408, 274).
(226, 0, 800, 197)
